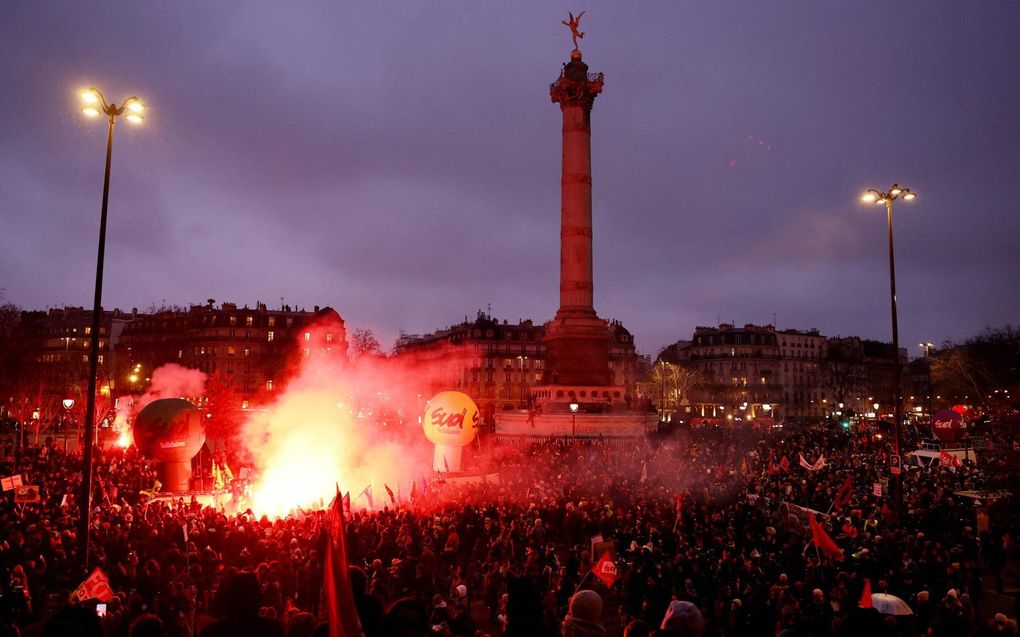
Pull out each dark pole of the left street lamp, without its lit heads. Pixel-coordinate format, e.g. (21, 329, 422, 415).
(78, 113, 116, 573)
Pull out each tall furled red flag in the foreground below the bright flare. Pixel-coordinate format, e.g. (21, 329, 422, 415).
(322, 489, 362, 637)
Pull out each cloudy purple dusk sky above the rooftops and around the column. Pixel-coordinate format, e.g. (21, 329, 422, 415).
(0, 0, 1020, 356)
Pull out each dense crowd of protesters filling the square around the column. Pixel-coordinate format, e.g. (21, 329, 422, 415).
(0, 417, 1020, 637)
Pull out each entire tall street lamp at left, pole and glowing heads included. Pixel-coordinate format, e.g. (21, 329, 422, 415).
(78, 89, 145, 573)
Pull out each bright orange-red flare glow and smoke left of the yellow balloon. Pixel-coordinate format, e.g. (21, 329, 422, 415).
(241, 328, 431, 518)
